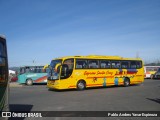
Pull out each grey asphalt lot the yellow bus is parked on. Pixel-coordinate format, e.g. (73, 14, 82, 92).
(10, 79, 160, 120)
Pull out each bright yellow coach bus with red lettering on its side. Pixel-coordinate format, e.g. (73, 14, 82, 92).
(47, 55, 144, 90)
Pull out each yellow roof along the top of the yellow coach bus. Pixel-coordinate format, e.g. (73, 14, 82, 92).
(53, 55, 142, 60)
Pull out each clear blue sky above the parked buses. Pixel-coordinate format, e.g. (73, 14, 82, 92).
(0, 0, 160, 66)
